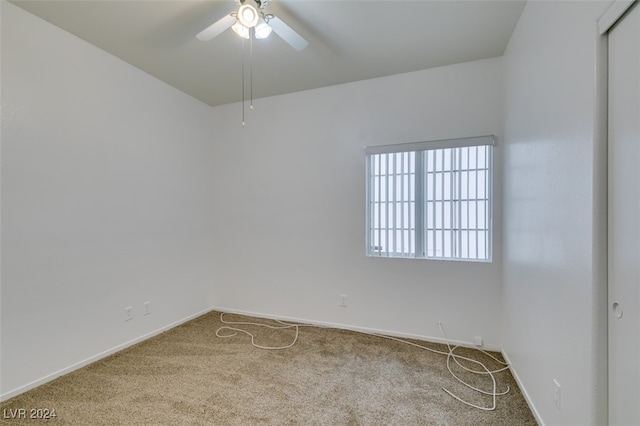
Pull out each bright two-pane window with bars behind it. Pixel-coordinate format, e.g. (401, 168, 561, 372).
(366, 136, 494, 262)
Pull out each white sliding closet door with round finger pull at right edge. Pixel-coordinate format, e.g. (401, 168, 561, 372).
(608, 2, 640, 425)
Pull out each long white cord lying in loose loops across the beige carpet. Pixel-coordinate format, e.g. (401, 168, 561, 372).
(216, 312, 510, 411)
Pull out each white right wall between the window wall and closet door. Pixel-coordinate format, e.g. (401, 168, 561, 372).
(503, 2, 608, 425)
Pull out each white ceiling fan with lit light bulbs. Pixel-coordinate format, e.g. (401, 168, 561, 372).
(196, 0, 309, 51)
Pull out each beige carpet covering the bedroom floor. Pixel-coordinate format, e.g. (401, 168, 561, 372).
(0, 312, 536, 426)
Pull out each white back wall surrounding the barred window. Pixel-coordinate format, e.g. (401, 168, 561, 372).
(212, 58, 502, 348)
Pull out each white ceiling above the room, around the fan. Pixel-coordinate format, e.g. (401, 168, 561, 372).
(12, 0, 524, 105)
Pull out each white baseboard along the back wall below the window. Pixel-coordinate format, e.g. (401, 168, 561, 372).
(212, 307, 502, 352)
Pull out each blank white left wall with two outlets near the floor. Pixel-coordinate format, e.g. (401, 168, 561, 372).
(0, 1, 216, 399)
